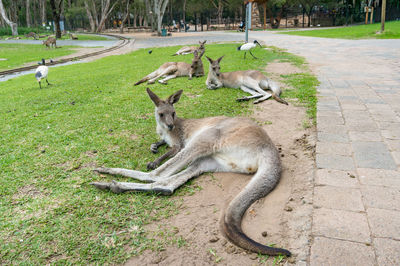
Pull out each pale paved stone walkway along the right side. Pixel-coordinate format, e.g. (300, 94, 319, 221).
(247, 33, 400, 265)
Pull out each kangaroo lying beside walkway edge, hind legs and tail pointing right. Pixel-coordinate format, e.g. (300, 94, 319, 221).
(206, 56, 288, 105)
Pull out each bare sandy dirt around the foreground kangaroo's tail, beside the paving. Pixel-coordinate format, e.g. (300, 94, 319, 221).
(127, 67, 316, 265)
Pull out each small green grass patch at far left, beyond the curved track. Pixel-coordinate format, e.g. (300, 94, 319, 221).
(0, 43, 77, 70)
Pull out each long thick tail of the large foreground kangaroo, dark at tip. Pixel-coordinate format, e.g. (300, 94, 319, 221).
(221, 149, 291, 256)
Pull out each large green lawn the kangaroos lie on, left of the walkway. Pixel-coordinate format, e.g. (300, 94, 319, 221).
(0, 44, 315, 265)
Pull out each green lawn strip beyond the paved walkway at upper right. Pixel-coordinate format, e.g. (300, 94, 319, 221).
(279, 21, 400, 39)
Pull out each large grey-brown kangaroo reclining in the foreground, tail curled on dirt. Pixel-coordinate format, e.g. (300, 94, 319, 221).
(91, 88, 291, 256)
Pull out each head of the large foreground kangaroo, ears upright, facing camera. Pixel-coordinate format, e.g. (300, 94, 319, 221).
(146, 88, 183, 131)
